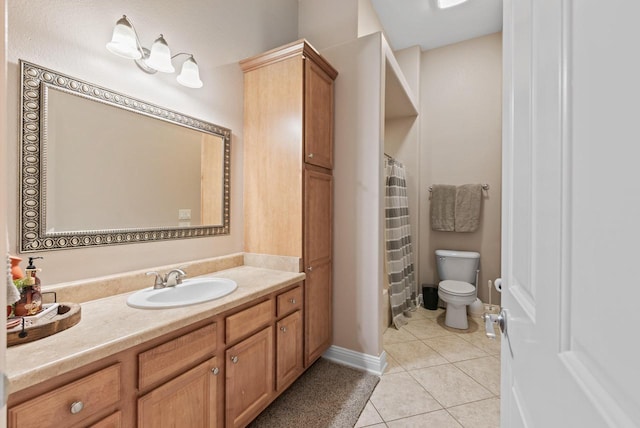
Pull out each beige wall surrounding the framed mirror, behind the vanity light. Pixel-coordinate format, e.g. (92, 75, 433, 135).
(2, 0, 298, 285)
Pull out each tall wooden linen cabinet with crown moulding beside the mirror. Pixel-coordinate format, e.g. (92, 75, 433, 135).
(240, 40, 338, 367)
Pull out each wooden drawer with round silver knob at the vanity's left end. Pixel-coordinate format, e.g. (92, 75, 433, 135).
(8, 364, 120, 428)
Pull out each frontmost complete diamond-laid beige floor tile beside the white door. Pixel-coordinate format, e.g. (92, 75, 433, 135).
(408, 364, 493, 408)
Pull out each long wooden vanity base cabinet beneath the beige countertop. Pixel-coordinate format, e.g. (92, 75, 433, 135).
(8, 282, 304, 428)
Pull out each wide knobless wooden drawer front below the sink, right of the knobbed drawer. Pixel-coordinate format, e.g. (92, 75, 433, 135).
(138, 323, 217, 390)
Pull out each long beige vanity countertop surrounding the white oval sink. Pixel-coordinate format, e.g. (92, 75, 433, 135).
(6, 266, 304, 393)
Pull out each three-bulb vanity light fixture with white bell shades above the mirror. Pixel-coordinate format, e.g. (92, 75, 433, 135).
(107, 15, 202, 88)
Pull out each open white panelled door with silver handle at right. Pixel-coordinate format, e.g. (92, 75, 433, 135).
(501, 0, 640, 428)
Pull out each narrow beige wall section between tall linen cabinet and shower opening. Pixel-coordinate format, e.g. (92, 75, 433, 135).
(322, 34, 384, 357)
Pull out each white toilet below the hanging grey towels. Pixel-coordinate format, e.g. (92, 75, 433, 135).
(436, 250, 480, 330)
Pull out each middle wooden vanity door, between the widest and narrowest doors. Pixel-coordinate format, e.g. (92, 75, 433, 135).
(225, 326, 274, 427)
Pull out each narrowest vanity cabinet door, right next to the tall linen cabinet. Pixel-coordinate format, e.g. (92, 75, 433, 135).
(276, 311, 303, 391)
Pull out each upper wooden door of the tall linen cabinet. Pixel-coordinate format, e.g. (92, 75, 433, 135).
(304, 59, 333, 169)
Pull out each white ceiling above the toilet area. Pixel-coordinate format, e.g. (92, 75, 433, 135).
(371, 0, 502, 50)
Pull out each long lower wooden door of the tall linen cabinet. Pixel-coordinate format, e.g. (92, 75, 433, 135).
(304, 170, 333, 367)
